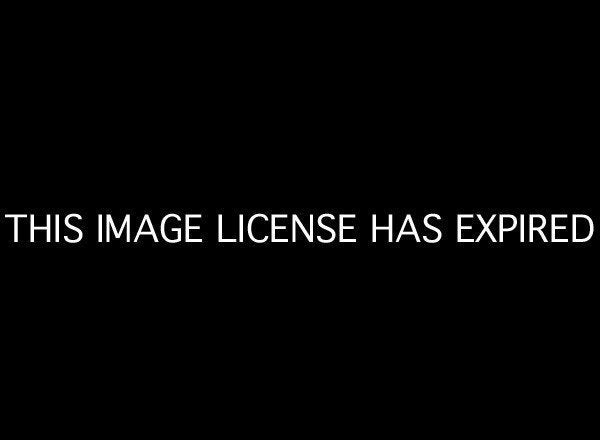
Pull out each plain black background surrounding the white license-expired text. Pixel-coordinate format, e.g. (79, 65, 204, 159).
(1, 5, 598, 433)
